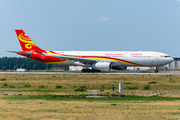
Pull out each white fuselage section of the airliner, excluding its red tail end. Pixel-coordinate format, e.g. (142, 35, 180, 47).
(53, 51, 174, 66)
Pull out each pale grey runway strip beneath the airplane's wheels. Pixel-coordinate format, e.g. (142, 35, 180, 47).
(0, 71, 180, 75)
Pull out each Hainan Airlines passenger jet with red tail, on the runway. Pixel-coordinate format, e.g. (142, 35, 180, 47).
(8, 29, 174, 73)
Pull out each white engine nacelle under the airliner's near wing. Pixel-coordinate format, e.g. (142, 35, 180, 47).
(92, 62, 111, 71)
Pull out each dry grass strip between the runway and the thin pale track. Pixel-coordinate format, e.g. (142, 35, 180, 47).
(0, 74, 180, 90)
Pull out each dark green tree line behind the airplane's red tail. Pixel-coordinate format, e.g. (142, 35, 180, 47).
(0, 57, 69, 71)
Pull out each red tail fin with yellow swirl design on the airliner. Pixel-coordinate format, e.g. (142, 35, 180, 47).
(15, 29, 45, 52)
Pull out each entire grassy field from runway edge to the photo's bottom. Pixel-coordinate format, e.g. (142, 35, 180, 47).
(0, 74, 180, 120)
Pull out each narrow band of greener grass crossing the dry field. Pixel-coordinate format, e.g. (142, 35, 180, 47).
(1, 94, 180, 102)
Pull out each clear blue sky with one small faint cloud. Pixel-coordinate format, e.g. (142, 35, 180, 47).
(0, 0, 180, 57)
